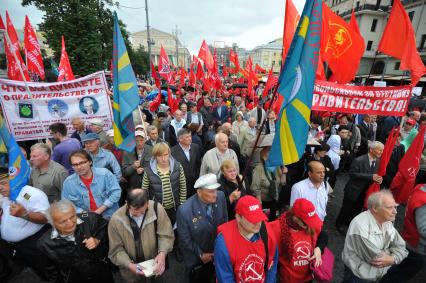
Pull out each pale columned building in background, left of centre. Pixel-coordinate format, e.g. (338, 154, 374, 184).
(130, 28, 191, 69)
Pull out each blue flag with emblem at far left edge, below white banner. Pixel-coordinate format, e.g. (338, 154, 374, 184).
(0, 115, 30, 201)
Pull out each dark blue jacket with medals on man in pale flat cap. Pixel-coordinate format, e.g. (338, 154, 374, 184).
(176, 191, 228, 269)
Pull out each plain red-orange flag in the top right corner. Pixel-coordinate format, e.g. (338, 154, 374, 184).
(377, 0, 426, 86)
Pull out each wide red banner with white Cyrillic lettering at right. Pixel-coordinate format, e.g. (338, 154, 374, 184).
(312, 80, 411, 116)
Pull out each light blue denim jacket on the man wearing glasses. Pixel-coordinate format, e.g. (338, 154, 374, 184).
(62, 167, 121, 219)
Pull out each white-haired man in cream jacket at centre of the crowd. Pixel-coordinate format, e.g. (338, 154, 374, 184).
(200, 133, 240, 176)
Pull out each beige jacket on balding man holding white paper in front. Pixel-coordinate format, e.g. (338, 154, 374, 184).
(108, 200, 174, 282)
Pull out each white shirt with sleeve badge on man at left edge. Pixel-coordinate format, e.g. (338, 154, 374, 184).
(0, 186, 49, 242)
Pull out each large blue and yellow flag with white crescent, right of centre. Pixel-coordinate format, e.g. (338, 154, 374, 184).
(267, 0, 321, 166)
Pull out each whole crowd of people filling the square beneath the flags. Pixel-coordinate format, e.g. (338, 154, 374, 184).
(0, 80, 426, 283)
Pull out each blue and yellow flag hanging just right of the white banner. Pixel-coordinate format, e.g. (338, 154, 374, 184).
(112, 13, 139, 152)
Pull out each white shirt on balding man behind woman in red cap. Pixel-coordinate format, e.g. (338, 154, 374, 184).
(290, 178, 328, 221)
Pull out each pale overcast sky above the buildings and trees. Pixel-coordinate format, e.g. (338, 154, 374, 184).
(0, 0, 305, 53)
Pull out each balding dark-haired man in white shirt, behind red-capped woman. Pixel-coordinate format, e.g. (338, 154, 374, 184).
(290, 161, 328, 221)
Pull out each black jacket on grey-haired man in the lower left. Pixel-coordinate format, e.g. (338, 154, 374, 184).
(38, 212, 112, 283)
